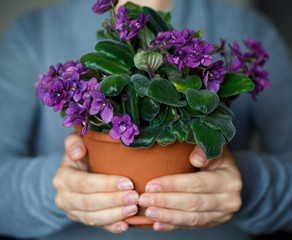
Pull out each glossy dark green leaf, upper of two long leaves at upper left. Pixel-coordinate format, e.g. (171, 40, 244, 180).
(95, 40, 134, 69)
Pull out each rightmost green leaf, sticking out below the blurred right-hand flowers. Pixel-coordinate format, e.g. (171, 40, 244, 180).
(218, 73, 254, 98)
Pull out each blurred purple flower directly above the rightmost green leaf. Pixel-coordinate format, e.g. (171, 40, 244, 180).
(229, 41, 248, 75)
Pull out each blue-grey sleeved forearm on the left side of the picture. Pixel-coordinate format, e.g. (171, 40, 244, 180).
(0, 153, 70, 238)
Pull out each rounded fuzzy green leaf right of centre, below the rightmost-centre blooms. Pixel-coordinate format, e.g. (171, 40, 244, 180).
(186, 89, 219, 114)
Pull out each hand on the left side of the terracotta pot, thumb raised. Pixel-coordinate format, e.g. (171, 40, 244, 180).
(53, 134, 139, 233)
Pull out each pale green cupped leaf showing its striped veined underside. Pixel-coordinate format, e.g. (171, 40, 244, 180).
(134, 50, 163, 77)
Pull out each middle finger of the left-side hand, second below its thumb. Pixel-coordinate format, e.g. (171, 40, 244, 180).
(60, 191, 139, 211)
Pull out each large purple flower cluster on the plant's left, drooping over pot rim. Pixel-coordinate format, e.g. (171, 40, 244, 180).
(35, 61, 139, 145)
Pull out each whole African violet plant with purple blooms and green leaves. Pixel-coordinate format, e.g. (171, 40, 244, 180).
(36, 0, 269, 159)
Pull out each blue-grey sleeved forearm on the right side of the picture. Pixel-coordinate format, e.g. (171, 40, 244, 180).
(233, 151, 292, 234)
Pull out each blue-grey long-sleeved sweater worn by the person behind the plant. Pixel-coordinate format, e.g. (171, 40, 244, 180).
(0, 0, 292, 240)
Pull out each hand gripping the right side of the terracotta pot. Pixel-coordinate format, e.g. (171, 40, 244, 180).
(139, 146, 242, 231)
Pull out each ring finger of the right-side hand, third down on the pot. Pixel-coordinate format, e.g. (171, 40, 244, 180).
(145, 207, 226, 228)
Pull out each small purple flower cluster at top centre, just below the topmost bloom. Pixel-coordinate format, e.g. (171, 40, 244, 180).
(115, 6, 150, 40)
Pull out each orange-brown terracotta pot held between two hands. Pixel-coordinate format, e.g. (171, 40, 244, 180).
(74, 126, 195, 228)
